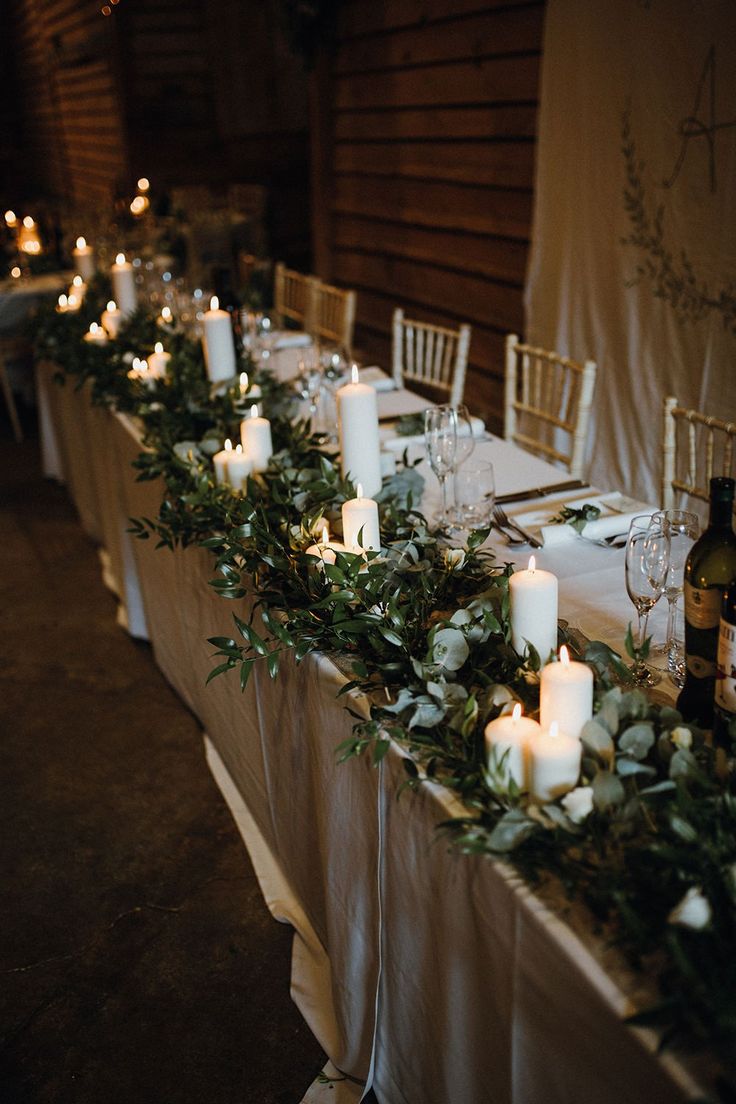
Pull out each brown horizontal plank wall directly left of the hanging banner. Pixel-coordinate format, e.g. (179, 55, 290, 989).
(313, 0, 544, 428)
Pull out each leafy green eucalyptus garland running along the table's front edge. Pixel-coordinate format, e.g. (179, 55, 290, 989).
(38, 280, 736, 1100)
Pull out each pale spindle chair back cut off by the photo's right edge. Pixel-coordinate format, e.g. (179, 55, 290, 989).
(662, 395, 736, 510)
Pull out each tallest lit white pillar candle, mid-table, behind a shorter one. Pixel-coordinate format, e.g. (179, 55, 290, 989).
(338, 364, 381, 496)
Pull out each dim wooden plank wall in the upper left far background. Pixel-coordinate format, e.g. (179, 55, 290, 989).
(10, 0, 126, 204)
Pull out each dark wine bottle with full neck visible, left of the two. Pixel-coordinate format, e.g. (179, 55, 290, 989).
(678, 476, 736, 729)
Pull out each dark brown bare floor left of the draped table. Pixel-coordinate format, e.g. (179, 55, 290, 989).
(0, 411, 324, 1104)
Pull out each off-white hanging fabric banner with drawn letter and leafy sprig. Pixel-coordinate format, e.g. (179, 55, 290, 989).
(525, 0, 736, 502)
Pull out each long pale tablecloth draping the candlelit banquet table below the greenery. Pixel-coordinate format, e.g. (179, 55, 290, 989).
(38, 364, 704, 1104)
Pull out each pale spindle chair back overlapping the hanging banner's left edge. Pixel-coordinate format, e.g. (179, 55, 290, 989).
(504, 333, 597, 478)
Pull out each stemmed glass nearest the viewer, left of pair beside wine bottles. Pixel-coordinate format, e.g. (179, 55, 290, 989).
(626, 513, 670, 687)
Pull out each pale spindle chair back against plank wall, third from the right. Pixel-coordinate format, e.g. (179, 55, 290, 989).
(392, 308, 470, 406)
